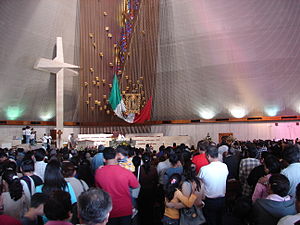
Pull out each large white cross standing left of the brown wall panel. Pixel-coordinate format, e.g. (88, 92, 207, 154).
(34, 37, 79, 148)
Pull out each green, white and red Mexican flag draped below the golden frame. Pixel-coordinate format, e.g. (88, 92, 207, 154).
(109, 75, 152, 123)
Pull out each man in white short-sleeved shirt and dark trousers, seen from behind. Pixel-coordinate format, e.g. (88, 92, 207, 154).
(199, 146, 229, 225)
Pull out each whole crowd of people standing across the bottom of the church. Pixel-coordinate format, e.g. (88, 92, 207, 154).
(0, 137, 300, 225)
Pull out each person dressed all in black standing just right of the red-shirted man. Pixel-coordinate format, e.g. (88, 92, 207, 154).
(137, 153, 158, 225)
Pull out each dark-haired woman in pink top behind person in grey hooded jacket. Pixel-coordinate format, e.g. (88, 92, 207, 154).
(252, 155, 280, 203)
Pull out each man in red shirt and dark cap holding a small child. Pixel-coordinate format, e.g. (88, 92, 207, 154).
(95, 147, 139, 225)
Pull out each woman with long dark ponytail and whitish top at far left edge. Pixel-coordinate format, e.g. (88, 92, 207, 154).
(1, 169, 29, 219)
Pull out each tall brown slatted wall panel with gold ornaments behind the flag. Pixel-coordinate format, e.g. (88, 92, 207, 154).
(80, 0, 159, 133)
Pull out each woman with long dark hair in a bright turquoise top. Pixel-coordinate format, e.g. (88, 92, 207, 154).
(36, 160, 77, 204)
